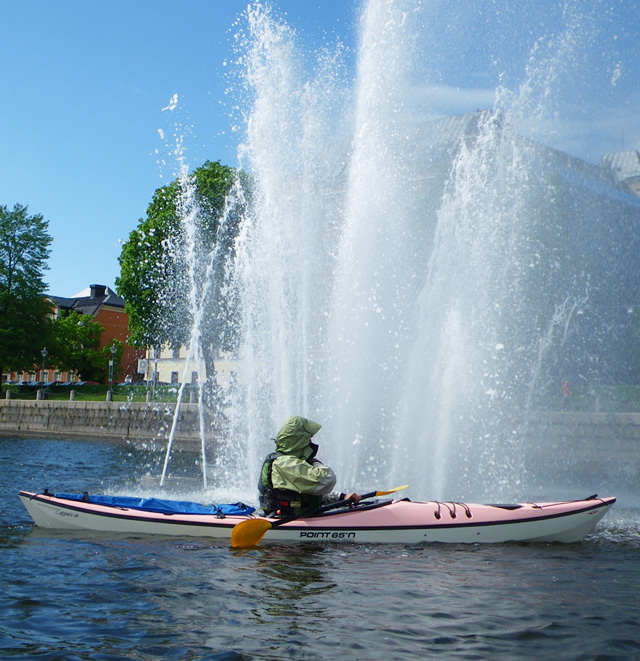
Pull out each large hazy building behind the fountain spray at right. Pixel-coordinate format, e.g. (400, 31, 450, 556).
(410, 111, 640, 387)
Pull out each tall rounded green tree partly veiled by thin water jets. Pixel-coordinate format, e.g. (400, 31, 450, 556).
(116, 161, 242, 374)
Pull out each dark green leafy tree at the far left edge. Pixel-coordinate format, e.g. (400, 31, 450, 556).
(0, 204, 52, 370)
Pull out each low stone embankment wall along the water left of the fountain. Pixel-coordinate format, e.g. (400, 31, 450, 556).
(0, 399, 200, 448)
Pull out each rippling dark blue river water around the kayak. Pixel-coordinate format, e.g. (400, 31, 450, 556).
(0, 438, 640, 660)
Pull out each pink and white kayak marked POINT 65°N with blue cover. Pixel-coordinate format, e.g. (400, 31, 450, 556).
(19, 491, 616, 544)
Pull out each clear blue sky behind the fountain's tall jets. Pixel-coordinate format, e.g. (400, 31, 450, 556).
(0, 0, 640, 296)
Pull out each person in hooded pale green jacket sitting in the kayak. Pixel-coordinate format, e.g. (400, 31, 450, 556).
(258, 415, 360, 514)
